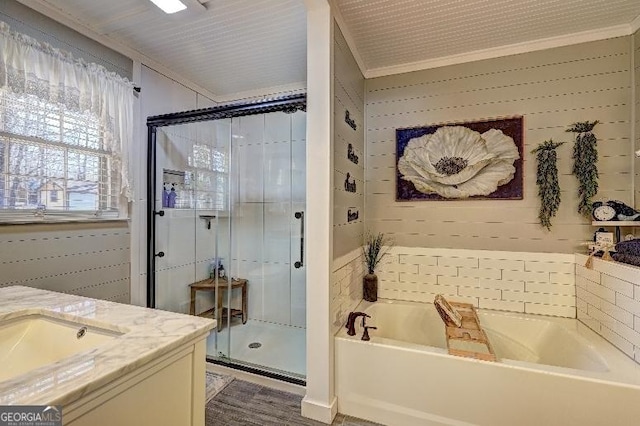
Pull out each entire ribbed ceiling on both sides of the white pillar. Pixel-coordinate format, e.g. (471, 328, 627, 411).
(20, 0, 640, 100)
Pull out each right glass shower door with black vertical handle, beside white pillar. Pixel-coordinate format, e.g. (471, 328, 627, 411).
(222, 112, 306, 377)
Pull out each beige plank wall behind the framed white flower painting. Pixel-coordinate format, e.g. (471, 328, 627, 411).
(365, 37, 633, 253)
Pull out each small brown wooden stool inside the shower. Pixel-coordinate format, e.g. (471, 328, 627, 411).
(189, 278, 248, 331)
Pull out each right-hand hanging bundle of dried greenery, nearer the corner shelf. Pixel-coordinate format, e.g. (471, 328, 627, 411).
(567, 120, 598, 217)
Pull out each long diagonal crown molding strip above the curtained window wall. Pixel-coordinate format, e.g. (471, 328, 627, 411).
(17, 0, 219, 103)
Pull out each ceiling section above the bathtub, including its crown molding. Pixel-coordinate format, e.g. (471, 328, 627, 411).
(335, 0, 640, 76)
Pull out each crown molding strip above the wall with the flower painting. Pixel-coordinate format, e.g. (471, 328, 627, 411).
(364, 23, 640, 78)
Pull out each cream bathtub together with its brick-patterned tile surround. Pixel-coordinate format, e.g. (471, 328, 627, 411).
(334, 247, 640, 426)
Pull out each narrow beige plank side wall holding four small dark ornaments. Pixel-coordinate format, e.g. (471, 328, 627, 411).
(333, 24, 365, 259)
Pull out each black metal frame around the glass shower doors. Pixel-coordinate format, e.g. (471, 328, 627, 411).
(146, 94, 307, 386)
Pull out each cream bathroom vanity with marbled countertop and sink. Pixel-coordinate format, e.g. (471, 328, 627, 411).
(0, 286, 215, 426)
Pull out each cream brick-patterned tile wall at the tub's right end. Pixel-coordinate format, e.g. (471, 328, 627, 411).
(576, 254, 640, 364)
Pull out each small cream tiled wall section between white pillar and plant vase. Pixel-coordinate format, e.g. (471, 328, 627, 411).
(330, 247, 366, 334)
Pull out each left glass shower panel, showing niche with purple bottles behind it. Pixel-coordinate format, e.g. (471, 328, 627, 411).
(155, 119, 231, 355)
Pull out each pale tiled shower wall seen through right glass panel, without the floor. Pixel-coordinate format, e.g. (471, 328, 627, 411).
(231, 111, 306, 327)
